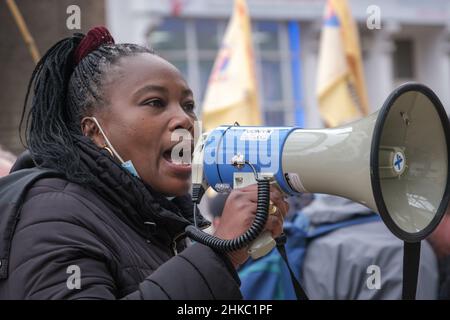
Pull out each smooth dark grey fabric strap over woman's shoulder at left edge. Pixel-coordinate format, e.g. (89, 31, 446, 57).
(0, 168, 61, 280)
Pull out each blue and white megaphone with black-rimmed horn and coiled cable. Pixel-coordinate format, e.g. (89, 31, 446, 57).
(187, 83, 450, 295)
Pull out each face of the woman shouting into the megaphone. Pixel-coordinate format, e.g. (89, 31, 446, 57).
(88, 53, 196, 196)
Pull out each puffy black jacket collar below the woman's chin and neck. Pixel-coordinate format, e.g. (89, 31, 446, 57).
(76, 136, 209, 242)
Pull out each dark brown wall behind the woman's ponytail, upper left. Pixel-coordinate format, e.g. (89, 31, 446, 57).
(0, 0, 105, 155)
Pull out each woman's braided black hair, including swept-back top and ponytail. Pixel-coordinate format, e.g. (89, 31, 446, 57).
(19, 34, 154, 184)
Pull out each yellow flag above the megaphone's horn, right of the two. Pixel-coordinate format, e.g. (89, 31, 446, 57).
(317, 0, 369, 127)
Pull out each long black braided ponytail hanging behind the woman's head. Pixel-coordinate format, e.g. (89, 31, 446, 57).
(19, 34, 82, 179)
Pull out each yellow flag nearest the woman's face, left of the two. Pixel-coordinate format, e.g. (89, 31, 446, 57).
(202, 0, 262, 130)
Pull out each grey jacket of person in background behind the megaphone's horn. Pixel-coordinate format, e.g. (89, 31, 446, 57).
(302, 194, 438, 300)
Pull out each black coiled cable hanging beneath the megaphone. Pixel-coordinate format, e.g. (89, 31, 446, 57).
(185, 176, 270, 252)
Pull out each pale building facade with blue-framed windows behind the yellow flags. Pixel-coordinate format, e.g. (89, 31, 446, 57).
(106, 0, 450, 128)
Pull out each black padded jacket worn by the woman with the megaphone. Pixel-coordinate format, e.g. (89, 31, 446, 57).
(0, 139, 242, 299)
